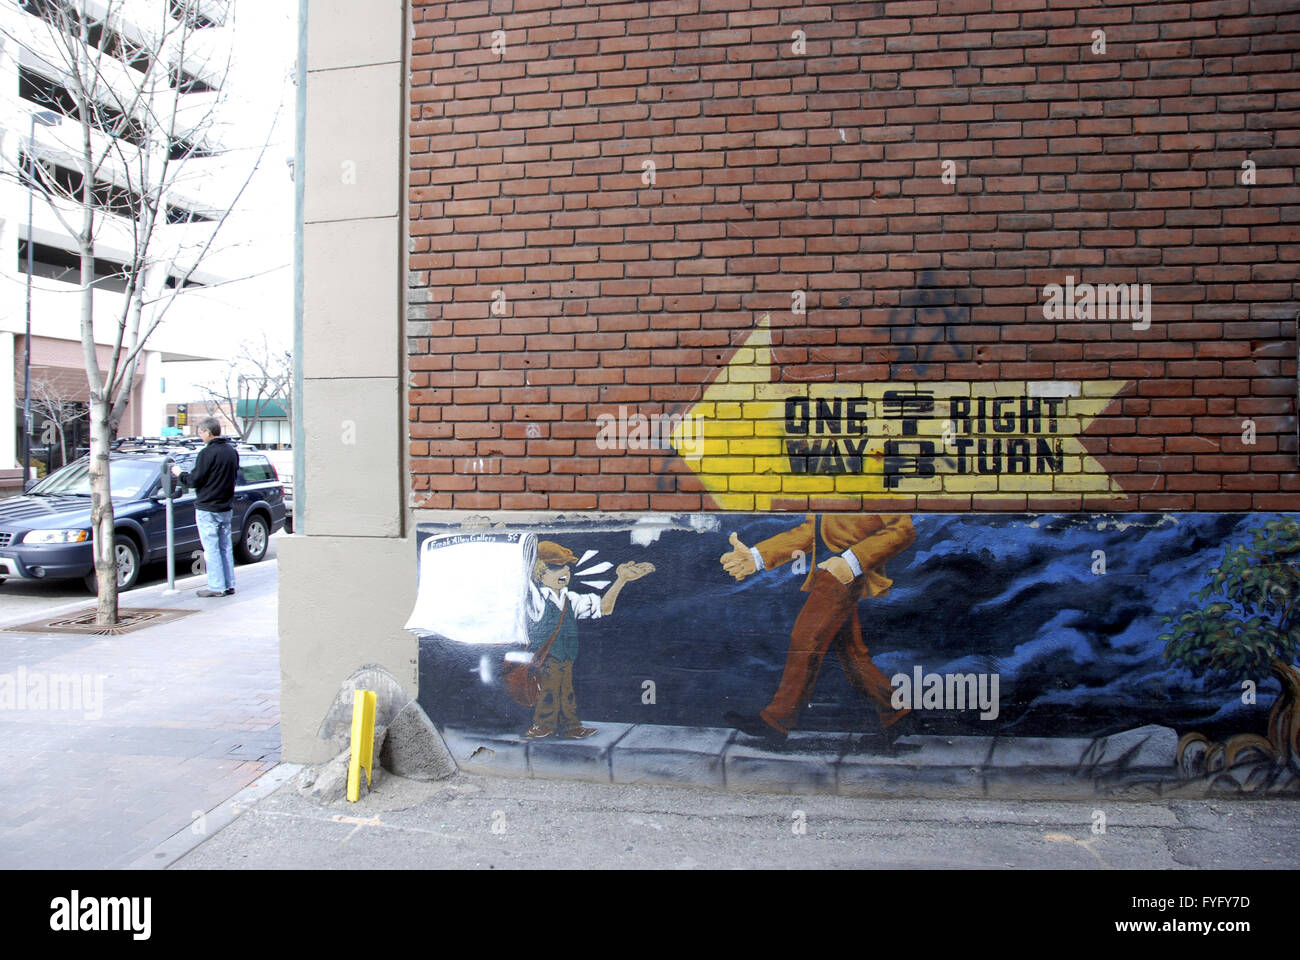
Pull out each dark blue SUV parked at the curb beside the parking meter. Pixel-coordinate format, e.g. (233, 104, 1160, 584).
(0, 441, 285, 592)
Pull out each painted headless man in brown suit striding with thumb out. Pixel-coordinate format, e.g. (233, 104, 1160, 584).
(720, 514, 917, 736)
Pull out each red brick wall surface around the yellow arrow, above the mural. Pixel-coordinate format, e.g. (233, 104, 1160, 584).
(408, 0, 1300, 510)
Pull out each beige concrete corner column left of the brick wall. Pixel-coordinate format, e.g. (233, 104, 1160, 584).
(280, 0, 417, 762)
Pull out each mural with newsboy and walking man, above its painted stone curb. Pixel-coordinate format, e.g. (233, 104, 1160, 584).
(407, 514, 1300, 791)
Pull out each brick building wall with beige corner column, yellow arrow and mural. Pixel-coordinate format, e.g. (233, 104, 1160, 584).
(289, 0, 1300, 793)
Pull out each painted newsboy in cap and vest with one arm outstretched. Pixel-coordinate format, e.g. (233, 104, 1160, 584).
(524, 540, 654, 740)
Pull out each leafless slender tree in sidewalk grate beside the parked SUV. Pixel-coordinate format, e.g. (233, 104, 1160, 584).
(7, 0, 279, 624)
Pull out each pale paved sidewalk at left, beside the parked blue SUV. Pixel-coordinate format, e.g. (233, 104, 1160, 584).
(0, 559, 280, 869)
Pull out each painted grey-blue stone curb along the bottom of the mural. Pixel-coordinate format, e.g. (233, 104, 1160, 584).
(442, 723, 1296, 800)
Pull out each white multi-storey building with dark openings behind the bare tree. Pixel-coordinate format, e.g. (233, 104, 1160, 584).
(0, 0, 229, 478)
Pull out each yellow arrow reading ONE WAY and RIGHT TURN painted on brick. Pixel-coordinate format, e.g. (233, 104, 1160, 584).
(671, 316, 1127, 510)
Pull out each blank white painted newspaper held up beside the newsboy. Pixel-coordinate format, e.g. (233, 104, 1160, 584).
(406, 533, 537, 645)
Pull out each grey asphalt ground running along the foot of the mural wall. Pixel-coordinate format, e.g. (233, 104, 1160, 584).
(173, 765, 1300, 870)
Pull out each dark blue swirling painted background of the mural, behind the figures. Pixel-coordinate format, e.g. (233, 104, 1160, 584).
(420, 514, 1289, 736)
